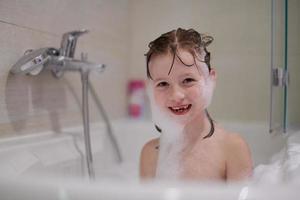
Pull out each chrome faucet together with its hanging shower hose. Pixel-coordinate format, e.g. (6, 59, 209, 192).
(10, 29, 121, 179)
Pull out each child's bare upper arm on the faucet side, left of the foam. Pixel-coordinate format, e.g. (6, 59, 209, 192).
(140, 138, 159, 179)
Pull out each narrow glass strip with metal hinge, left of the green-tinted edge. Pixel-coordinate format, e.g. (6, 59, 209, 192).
(269, 0, 286, 133)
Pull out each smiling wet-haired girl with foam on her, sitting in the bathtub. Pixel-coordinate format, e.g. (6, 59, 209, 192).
(140, 28, 252, 180)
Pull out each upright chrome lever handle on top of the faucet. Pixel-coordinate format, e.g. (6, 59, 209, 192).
(60, 29, 89, 58)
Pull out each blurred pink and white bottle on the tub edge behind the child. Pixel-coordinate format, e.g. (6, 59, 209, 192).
(128, 80, 145, 119)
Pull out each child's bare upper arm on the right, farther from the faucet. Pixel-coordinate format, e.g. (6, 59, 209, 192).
(226, 134, 253, 181)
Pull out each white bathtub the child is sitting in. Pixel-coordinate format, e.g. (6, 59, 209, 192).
(0, 119, 300, 200)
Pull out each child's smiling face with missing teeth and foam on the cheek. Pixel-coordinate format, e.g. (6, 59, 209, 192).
(149, 50, 215, 124)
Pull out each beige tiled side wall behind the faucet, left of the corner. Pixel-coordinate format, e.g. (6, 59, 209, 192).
(0, 0, 129, 137)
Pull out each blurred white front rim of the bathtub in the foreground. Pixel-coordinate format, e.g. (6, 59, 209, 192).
(0, 174, 300, 199)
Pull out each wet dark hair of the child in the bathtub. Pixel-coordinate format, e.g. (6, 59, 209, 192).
(145, 28, 215, 139)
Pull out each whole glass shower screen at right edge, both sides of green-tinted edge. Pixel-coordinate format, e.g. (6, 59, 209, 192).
(269, 0, 300, 133)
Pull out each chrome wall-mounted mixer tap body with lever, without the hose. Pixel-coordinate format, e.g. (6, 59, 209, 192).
(10, 29, 105, 78)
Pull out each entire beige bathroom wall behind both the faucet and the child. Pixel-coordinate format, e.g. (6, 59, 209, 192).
(0, 0, 300, 137)
